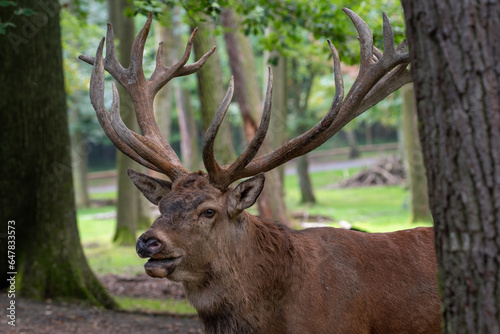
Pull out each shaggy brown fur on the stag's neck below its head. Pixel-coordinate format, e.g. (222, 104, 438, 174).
(184, 212, 300, 333)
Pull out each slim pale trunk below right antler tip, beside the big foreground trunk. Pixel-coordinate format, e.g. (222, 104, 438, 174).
(402, 84, 432, 223)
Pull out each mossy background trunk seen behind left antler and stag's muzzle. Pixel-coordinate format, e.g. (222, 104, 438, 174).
(108, 0, 140, 245)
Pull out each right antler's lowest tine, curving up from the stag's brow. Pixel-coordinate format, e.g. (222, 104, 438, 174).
(202, 77, 234, 184)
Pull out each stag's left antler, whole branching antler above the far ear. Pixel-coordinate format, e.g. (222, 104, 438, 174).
(79, 13, 215, 181)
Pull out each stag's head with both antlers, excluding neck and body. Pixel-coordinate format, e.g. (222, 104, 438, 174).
(80, 9, 411, 284)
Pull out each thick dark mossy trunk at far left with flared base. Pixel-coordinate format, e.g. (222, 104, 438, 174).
(0, 0, 115, 308)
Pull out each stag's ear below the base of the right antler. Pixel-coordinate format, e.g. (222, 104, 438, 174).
(227, 174, 266, 217)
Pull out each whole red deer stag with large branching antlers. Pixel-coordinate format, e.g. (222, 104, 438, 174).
(80, 9, 440, 334)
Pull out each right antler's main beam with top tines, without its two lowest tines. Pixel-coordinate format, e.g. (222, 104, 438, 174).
(225, 8, 411, 183)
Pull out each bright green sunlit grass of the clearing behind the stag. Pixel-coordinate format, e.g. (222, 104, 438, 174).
(78, 168, 431, 314)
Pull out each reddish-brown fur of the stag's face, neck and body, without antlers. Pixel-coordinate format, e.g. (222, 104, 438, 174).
(135, 174, 440, 334)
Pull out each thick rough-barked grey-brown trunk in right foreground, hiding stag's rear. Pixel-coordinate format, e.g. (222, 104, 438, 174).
(403, 0, 500, 333)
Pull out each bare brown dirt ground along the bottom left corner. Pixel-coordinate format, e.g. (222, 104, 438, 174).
(0, 293, 203, 334)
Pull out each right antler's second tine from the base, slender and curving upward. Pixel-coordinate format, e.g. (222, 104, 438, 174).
(221, 67, 273, 188)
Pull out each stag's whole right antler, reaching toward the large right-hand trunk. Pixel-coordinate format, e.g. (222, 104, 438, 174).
(203, 8, 411, 189)
